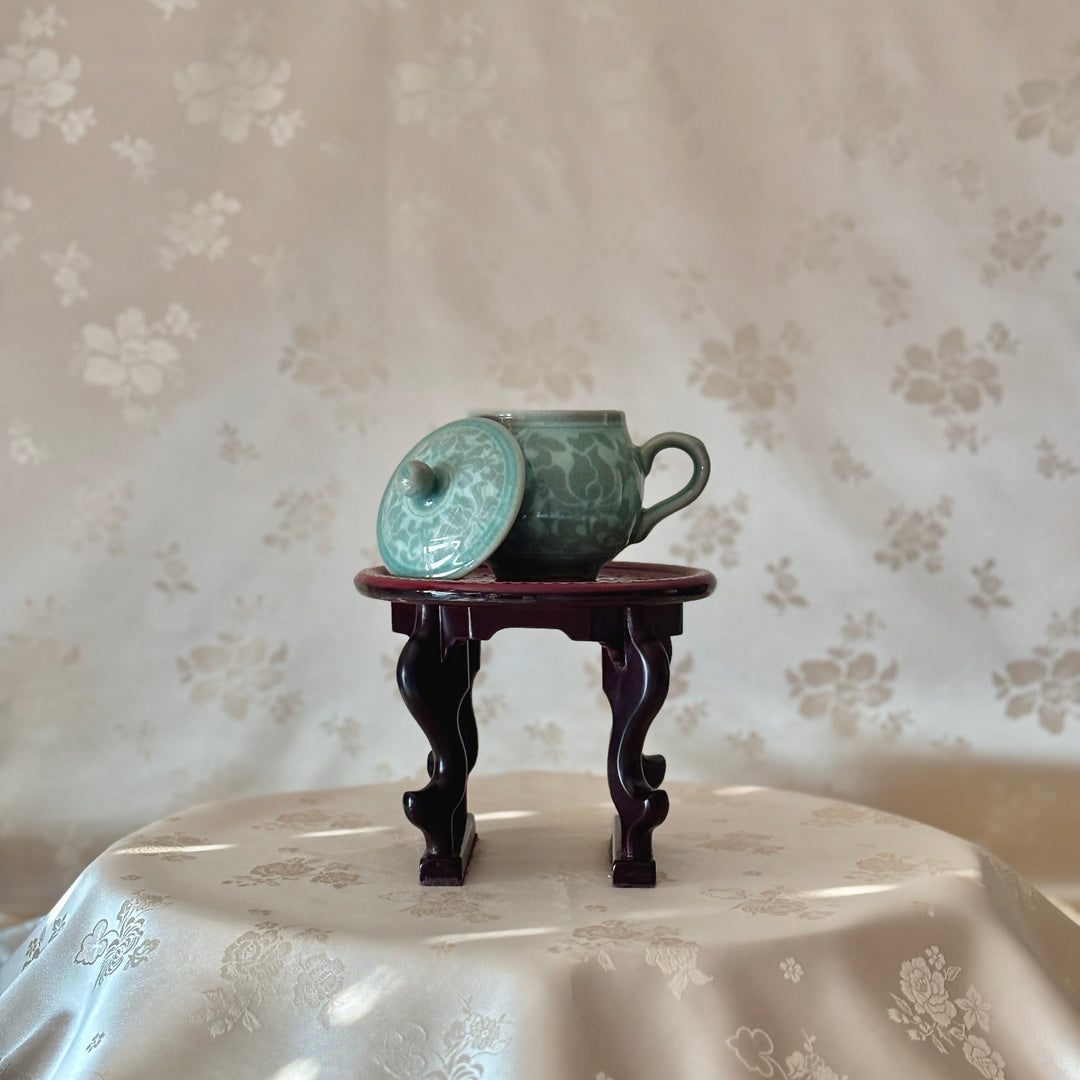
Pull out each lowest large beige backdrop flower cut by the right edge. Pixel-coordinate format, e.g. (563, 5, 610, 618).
(993, 607, 1080, 734)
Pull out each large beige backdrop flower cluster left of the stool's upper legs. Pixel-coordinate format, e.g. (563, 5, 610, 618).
(176, 597, 299, 723)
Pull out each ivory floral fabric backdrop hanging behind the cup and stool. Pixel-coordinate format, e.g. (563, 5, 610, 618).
(0, 0, 1080, 917)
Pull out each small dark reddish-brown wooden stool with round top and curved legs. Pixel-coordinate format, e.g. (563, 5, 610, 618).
(355, 563, 716, 887)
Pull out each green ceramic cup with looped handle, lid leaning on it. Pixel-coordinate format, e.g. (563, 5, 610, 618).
(472, 410, 710, 581)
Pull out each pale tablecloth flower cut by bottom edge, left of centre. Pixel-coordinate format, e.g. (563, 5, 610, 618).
(377, 997, 511, 1080)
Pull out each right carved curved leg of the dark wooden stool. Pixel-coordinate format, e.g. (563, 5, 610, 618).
(603, 607, 671, 887)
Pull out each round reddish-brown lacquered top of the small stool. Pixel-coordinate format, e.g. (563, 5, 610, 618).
(354, 563, 716, 607)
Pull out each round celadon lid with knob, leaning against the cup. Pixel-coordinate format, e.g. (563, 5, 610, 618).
(377, 417, 525, 579)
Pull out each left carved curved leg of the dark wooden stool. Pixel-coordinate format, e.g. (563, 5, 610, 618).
(397, 604, 478, 885)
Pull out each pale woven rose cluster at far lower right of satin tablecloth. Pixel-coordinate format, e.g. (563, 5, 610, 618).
(888, 945, 1005, 1080)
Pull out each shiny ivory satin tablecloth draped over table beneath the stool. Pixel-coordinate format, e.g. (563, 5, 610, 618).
(0, 773, 1080, 1080)
